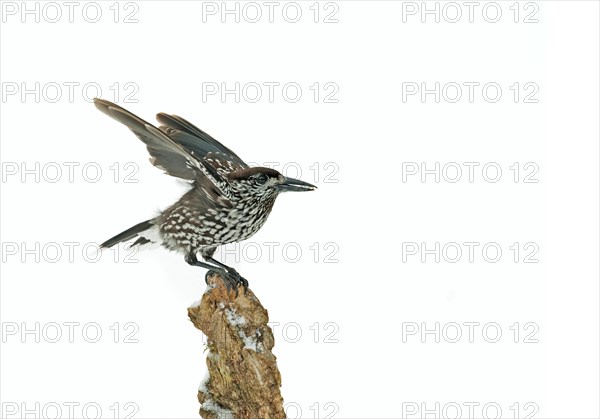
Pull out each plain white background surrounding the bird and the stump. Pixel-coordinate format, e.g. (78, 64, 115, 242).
(0, 1, 600, 418)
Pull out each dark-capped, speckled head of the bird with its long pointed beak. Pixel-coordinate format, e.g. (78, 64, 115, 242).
(228, 167, 317, 198)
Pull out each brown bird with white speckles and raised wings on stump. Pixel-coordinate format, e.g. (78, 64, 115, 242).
(94, 98, 317, 296)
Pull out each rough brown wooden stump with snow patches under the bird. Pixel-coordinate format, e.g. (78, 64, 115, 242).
(188, 275, 285, 419)
